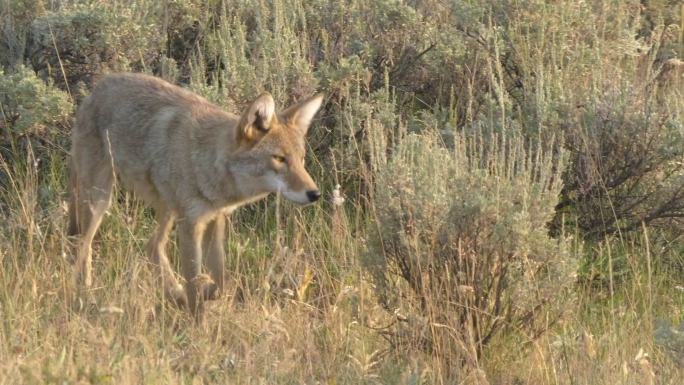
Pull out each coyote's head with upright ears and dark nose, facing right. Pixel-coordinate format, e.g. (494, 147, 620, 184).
(229, 93, 323, 204)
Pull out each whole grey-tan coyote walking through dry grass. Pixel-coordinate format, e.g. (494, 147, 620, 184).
(68, 74, 323, 317)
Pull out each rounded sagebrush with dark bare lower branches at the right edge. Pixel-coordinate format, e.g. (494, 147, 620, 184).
(556, 80, 684, 238)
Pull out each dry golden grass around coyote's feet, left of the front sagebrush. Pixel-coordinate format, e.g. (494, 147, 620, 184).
(0, 148, 400, 384)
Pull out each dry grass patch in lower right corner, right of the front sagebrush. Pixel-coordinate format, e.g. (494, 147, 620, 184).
(492, 238, 684, 384)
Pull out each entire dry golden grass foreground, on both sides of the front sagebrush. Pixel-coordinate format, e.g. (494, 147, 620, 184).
(0, 133, 684, 385)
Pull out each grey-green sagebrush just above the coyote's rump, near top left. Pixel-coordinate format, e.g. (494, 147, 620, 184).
(27, 4, 162, 96)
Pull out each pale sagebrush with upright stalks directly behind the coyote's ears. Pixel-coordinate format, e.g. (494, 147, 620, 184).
(190, 1, 317, 109)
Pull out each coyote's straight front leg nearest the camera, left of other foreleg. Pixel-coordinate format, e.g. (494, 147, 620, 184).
(178, 218, 214, 320)
